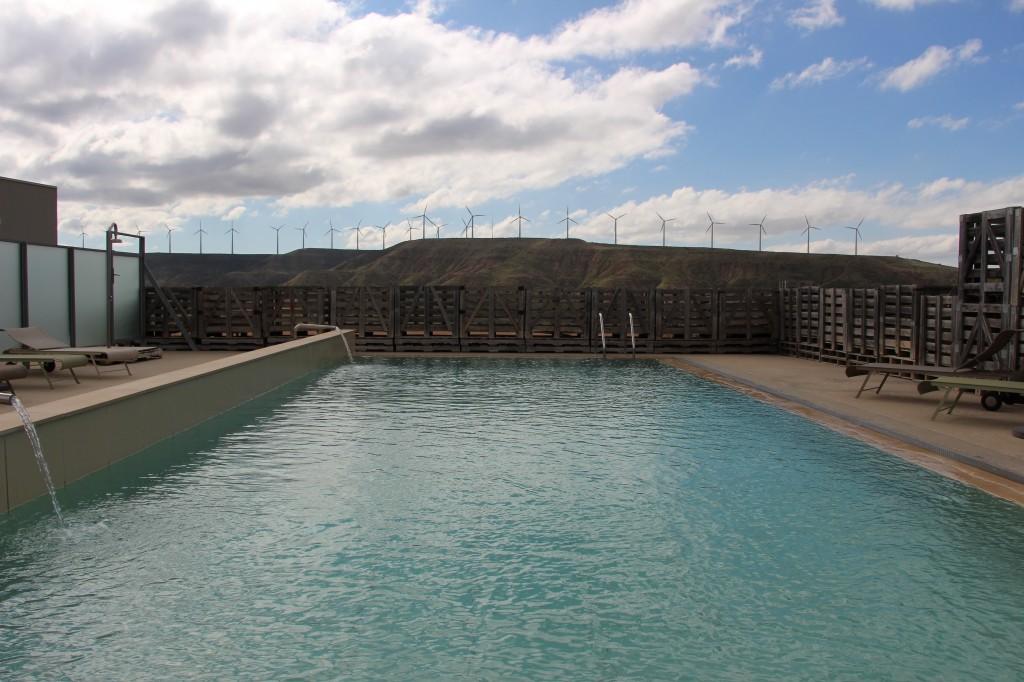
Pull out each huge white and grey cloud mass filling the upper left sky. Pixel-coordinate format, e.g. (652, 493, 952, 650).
(0, 0, 724, 231)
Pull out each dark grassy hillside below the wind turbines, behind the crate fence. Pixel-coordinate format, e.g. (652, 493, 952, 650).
(147, 239, 956, 289)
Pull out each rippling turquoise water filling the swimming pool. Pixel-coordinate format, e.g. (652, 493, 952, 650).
(0, 358, 1024, 680)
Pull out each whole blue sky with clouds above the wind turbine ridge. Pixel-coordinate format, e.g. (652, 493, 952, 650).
(0, 0, 1024, 264)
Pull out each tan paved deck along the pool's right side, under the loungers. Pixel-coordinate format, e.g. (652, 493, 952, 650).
(662, 355, 1024, 504)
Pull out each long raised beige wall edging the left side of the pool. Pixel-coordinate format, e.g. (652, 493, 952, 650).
(0, 329, 354, 512)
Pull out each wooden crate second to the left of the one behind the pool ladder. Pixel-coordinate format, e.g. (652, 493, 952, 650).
(459, 287, 526, 352)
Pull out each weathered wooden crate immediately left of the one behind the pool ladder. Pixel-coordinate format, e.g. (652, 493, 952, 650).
(523, 289, 591, 352)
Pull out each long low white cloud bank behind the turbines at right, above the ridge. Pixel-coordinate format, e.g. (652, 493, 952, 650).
(574, 175, 1024, 263)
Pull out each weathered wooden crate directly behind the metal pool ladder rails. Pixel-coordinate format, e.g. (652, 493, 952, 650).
(590, 289, 655, 353)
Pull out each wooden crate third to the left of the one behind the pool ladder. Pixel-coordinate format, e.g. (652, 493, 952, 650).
(394, 287, 461, 352)
